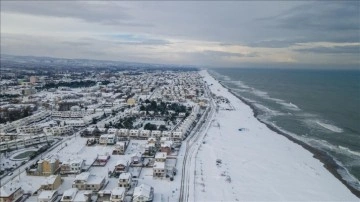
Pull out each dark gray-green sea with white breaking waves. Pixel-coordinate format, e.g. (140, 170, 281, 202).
(209, 68, 360, 190)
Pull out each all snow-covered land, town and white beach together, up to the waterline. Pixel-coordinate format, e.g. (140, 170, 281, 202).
(0, 57, 355, 202)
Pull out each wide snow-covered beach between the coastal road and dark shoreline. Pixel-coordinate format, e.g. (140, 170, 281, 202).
(190, 71, 359, 201)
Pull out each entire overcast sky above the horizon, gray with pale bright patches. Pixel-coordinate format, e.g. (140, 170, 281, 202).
(1, 1, 360, 68)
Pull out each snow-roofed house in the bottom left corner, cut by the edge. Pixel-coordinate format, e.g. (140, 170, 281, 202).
(0, 182, 24, 202)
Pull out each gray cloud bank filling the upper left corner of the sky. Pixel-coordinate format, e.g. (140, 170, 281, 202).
(1, 1, 152, 27)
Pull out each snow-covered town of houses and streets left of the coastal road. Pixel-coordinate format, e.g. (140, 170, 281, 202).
(0, 64, 209, 202)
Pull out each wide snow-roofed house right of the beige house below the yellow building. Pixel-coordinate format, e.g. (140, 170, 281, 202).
(72, 172, 105, 191)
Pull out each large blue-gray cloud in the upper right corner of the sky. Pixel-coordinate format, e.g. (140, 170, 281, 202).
(259, 1, 360, 44)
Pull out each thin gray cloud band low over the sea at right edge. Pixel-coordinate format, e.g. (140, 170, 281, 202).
(295, 45, 360, 55)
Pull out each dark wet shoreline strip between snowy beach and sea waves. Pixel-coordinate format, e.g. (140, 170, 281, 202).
(208, 72, 360, 198)
